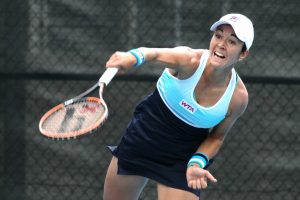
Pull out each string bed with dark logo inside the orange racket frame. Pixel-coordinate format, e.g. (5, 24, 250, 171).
(42, 101, 106, 134)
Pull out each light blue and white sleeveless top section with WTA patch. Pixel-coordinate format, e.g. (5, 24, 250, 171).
(156, 50, 237, 128)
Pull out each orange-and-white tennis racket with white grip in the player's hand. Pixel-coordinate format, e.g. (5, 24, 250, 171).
(39, 68, 118, 139)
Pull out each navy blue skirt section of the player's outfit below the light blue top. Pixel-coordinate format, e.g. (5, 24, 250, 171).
(109, 89, 209, 196)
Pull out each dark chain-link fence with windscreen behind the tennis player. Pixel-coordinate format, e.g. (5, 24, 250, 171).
(0, 0, 300, 200)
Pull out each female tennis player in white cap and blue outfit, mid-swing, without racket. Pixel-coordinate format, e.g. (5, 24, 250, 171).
(104, 14, 254, 200)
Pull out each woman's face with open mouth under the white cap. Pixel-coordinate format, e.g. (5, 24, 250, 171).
(209, 24, 249, 67)
